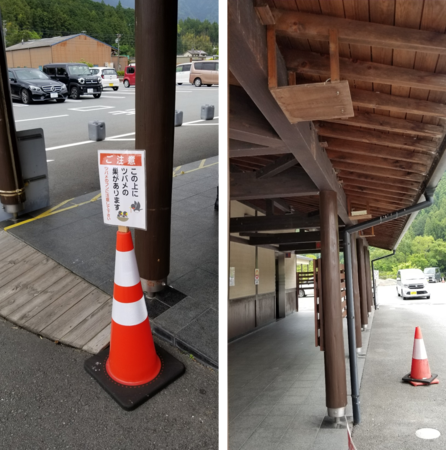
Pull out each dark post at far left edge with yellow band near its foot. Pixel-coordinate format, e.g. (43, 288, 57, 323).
(0, 13, 26, 218)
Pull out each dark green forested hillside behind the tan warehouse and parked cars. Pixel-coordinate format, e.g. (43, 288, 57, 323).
(0, 0, 219, 56)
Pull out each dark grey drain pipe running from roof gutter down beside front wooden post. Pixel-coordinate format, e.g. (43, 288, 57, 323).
(344, 187, 435, 425)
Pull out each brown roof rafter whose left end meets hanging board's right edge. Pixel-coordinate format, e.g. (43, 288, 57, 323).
(351, 88, 446, 117)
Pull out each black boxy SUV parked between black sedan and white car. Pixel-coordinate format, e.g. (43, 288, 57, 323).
(43, 63, 102, 99)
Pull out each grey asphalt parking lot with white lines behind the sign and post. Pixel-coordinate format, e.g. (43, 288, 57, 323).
(13, 83, 219, 205)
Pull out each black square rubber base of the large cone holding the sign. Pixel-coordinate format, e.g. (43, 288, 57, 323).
(84, 344, 185, 411)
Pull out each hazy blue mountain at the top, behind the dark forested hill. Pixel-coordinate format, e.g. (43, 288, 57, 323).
(90, 0, 219, 23)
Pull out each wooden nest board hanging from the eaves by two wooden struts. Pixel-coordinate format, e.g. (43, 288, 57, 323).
(267, 20, 354, 123)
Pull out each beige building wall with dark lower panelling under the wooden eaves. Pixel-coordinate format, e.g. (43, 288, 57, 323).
(228, 202, 276, 339)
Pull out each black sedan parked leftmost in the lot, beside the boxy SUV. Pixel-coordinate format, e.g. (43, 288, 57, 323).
(8, 68, 68, 105)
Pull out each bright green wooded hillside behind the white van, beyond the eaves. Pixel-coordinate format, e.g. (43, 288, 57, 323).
(371, 174, 446, 278)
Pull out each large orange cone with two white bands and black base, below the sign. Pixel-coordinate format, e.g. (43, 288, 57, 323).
(84, 231, 185, 411)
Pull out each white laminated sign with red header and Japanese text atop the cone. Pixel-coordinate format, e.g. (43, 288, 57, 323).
(98, 150, 146, 230)
